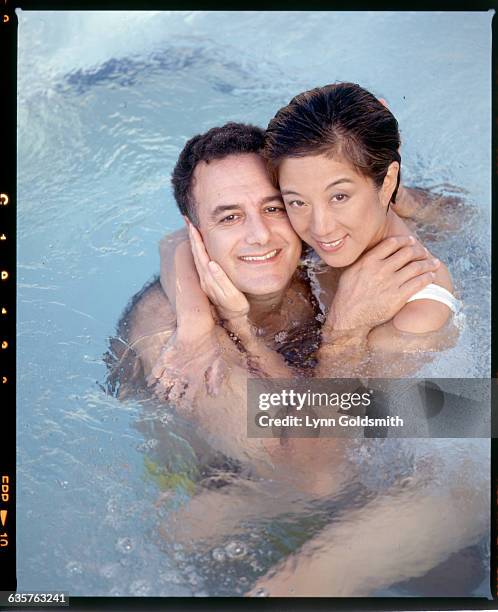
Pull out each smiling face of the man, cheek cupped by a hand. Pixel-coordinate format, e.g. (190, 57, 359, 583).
(193, 153, 301, 296)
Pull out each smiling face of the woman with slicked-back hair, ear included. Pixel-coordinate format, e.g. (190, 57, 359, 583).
(279, 155, 398, 268)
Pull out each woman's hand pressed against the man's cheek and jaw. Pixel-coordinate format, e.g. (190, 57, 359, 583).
(186, 220, 249, 321)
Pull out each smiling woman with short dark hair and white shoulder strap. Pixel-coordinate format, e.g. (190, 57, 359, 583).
(263, 83, 456, 348)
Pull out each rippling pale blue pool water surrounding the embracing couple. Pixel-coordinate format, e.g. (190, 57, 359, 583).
(17, 11, 492, 596)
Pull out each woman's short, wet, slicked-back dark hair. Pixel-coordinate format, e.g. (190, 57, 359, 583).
(262, 83, 401, 203)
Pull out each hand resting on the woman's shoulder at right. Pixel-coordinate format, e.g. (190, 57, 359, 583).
(323, 236, 440, 340)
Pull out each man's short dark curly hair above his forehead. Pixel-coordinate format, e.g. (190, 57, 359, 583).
(171, 122, 264, 226)
